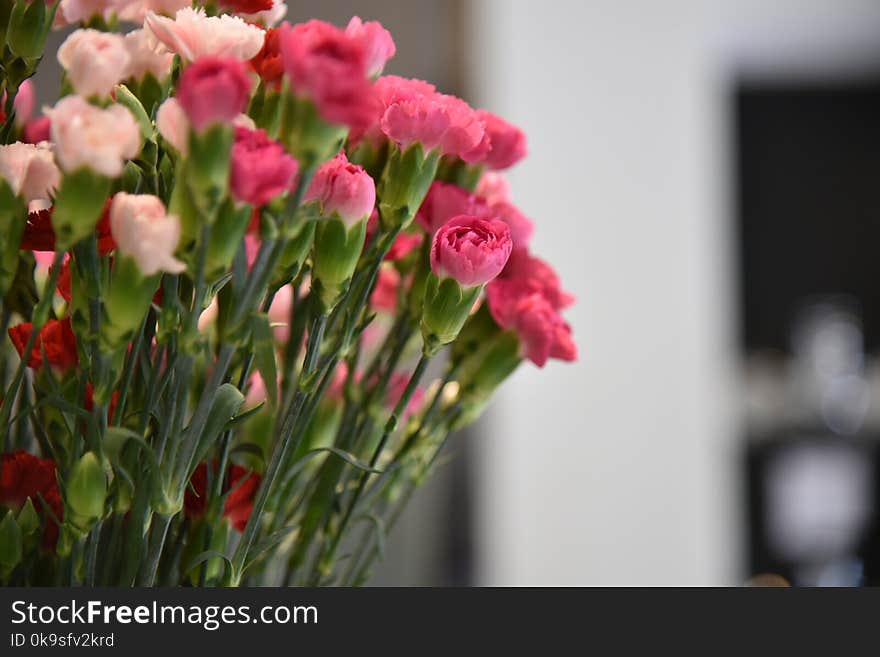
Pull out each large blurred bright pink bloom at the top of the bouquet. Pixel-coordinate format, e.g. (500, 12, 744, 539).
(280, 20, 375, 130)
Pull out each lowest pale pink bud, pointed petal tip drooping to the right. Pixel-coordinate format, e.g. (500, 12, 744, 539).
(110, 192, 186, 276)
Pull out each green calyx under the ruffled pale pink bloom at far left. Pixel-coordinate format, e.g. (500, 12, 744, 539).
(52, 168, 111, 251)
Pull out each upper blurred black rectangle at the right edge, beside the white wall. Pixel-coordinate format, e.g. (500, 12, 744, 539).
(736, 79, 880, 351)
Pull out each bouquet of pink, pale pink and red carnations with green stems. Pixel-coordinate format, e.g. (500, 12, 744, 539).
(0, 0, 575, 586)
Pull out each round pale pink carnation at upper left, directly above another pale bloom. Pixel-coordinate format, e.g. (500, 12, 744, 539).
(58, 29, 131, 97)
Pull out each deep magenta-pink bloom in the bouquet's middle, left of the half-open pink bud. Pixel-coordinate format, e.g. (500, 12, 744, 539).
(229, 127, 299, 206)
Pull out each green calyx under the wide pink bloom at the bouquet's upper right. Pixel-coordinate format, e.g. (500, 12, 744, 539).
(376, 142, 440, 231)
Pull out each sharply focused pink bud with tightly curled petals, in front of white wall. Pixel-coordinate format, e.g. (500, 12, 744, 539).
(431, 215, 513, 287)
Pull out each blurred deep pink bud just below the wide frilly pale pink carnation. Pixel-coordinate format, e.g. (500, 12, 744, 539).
(177, 57, 251, 132)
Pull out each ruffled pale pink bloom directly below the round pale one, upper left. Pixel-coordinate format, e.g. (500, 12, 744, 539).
(45, 96, 141, 178)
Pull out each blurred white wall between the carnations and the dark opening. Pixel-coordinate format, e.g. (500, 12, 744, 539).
(466, 0, 880, 585)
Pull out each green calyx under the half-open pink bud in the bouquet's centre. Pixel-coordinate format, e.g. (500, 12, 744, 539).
(312, 217, 367, 310)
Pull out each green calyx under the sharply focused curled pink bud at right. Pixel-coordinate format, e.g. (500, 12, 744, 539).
(421, 272, 483, 356)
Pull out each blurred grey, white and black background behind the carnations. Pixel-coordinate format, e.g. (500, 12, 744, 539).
(41, 0, 880, 586)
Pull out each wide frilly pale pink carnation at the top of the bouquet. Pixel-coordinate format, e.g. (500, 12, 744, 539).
(144, 7, 265, 62)
